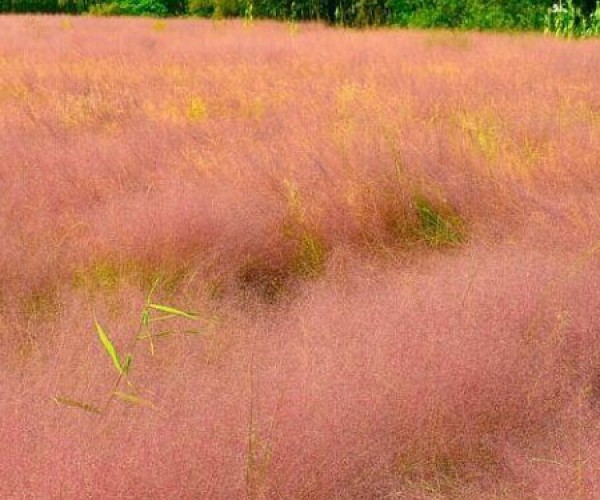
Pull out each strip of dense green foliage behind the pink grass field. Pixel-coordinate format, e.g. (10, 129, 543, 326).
(0, 0, 600, 34)
